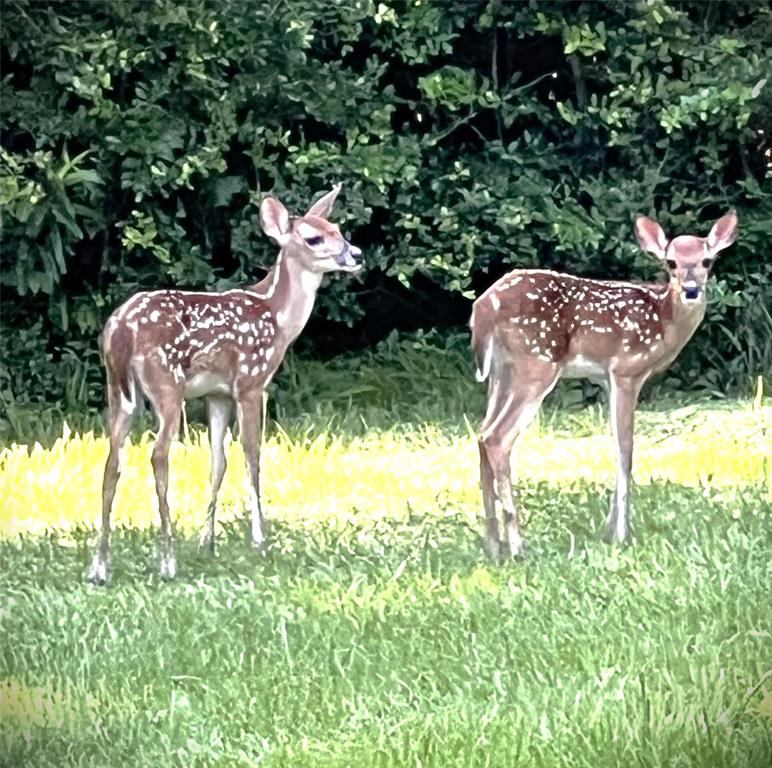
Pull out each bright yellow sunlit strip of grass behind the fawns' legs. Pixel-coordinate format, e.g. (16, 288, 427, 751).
(0, 406, 772, 536)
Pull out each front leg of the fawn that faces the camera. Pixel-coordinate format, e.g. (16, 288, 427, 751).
(606, 376, 641, 544)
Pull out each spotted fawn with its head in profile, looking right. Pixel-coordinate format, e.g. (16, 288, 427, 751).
(89, 185, 362, 584)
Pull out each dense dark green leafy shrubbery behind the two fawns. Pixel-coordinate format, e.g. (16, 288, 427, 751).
(0, 0, 772, 438)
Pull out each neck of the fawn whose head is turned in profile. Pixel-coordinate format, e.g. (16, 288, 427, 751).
(250, 250, 322, 346)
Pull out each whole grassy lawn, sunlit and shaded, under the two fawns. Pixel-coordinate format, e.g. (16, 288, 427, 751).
(0, 352, 772, 768)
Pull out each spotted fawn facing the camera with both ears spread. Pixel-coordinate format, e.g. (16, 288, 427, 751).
(470, 211, 737, 559)
